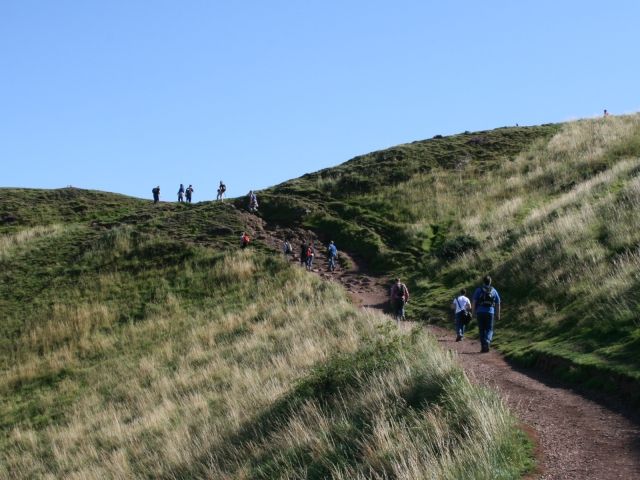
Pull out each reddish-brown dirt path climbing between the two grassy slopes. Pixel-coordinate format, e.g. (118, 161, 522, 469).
(241, 211, 640, 480)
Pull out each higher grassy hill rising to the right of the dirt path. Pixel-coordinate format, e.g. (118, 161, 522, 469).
(261, 115, 640, 402)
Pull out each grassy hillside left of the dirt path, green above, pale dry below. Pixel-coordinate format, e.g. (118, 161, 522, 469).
(0, 189, 531, 479)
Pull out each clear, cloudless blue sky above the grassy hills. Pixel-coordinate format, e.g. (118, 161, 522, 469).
(0, 0, 640, 201)
